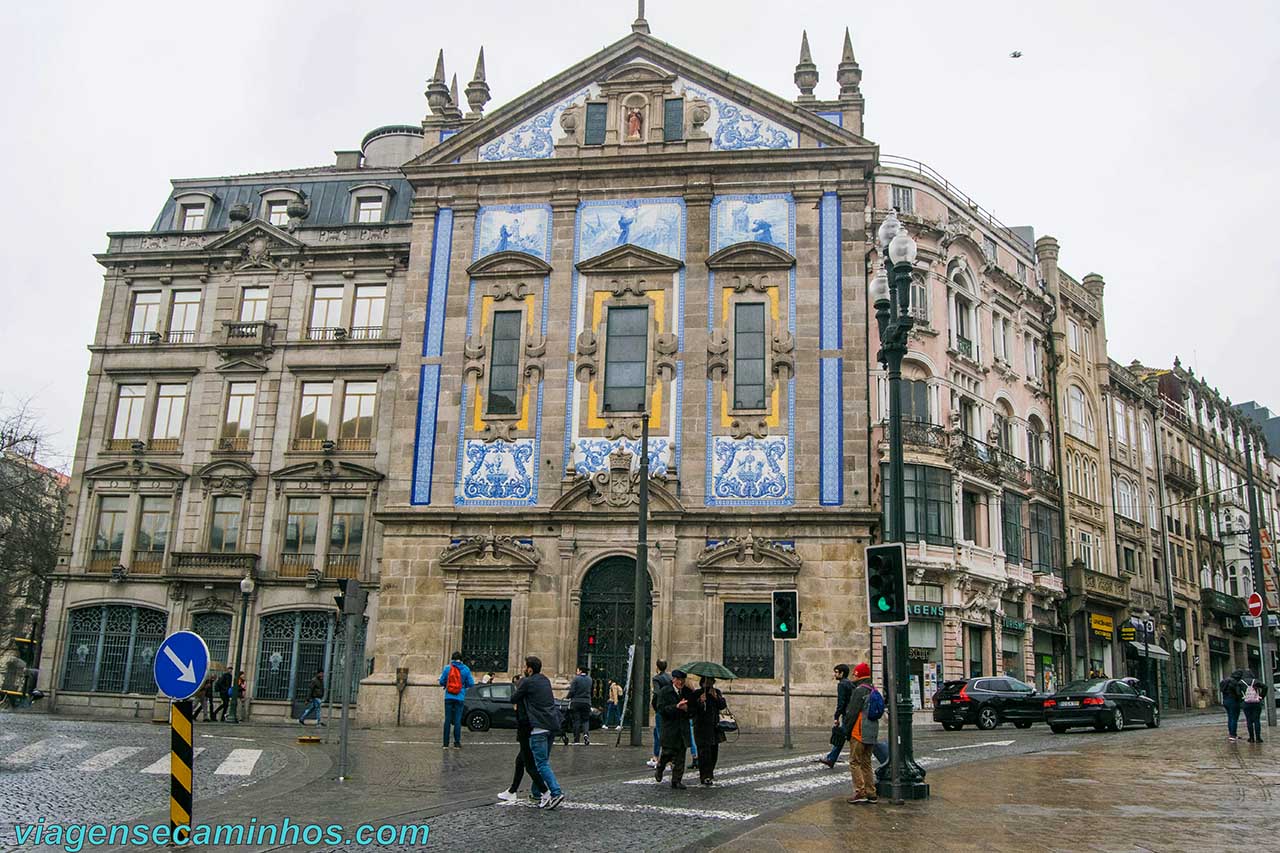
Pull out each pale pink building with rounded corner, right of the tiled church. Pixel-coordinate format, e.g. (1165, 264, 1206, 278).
(868, 158, 1065, 704)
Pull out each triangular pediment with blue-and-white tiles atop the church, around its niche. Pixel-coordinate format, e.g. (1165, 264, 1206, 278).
(403, 33, 870, 167)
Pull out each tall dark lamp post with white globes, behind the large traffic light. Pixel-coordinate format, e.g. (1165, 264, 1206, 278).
(870, 213, 929, 800)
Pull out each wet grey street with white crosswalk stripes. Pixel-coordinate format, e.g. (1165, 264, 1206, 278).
(0, 701, 1217, 853)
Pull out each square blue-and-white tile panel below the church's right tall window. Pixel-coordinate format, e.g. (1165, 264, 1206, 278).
(708, 435, 795, 506)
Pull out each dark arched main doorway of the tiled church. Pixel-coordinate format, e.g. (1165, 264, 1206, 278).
(577, 556, 653, 716)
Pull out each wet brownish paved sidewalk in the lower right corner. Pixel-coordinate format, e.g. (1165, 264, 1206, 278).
(716, 721, 1280, 853)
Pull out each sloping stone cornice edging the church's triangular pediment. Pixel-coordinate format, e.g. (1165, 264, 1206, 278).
(404, 32, 872, 167)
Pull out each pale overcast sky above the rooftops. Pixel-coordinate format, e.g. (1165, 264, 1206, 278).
(0, 0, 1280, 466)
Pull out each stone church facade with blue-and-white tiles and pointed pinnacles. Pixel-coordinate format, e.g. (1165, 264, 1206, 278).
(361, 19, 877, 726)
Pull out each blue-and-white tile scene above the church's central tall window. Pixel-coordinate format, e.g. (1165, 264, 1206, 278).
(577, 199, 685, 261)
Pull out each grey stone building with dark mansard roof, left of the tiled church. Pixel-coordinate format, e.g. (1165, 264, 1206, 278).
(41, 128, 421, 715)
